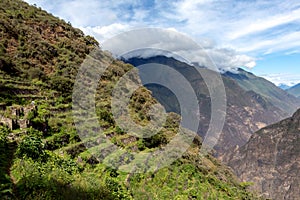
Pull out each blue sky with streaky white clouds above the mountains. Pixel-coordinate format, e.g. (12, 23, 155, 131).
(25, 0, 300, 85)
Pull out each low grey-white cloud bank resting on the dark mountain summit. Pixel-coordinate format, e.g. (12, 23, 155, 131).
(102, 28, 256, 71)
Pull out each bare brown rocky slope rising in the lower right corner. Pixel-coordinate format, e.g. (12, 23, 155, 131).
(227, 110, 300, 200)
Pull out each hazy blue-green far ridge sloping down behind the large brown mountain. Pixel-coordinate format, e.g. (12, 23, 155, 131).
(224, 69, 300, 117)
